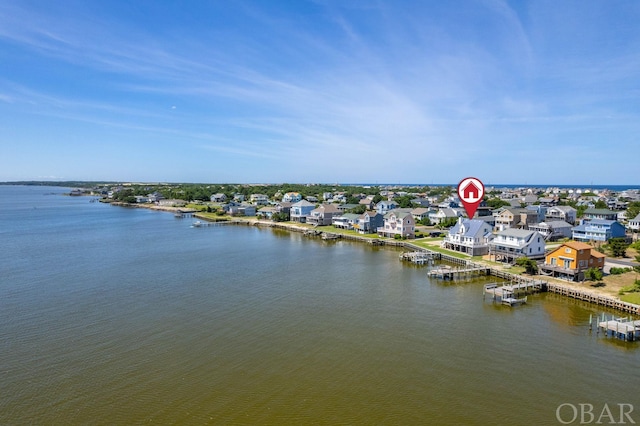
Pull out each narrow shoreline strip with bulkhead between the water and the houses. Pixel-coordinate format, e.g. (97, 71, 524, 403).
(108, 202, 640, 315)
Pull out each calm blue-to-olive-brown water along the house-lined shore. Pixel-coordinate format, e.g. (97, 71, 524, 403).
(0, 186, 640, 425)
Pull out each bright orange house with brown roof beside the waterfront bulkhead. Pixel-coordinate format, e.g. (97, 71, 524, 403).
(540, 241, 605, 281)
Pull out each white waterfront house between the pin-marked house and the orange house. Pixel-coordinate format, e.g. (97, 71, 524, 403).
(489, 228, 545, 263)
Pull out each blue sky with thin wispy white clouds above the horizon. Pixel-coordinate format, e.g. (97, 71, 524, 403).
(0, 0, 640, 184)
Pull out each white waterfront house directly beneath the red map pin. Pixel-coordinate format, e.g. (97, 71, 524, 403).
(442, 218, 493, 256)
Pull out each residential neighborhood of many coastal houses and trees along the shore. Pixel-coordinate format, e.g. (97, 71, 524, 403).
(103, 180, 640, 281)
